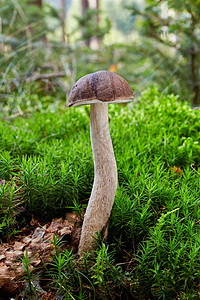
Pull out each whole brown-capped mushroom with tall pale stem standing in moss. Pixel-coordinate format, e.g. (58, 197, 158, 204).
(68, 71, 134, 257)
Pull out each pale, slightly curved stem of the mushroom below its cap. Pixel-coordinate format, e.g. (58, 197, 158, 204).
(78, 103, 117, 257)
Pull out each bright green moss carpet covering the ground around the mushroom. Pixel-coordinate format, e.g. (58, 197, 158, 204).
(0, 87, 200, 299)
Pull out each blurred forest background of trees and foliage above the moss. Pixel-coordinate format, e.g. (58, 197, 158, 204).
(0, 0, 200, 107)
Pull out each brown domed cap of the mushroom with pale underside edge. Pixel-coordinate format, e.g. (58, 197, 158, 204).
(68, 71, 134, 106)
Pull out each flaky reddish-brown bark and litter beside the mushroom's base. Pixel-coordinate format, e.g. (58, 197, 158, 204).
(0, 212, 82, 299)
